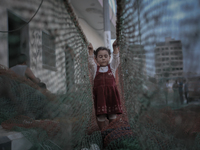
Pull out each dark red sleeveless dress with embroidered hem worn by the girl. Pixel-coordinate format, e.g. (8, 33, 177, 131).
(93, 65, 122, 115)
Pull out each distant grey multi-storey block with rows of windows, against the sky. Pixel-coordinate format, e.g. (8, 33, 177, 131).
(155, 37, 183, 80)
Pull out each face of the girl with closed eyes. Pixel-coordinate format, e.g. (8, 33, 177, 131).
(96, 50, 110, 67)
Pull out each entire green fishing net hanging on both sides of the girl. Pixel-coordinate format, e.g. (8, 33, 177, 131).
(0, 0, 200, 150)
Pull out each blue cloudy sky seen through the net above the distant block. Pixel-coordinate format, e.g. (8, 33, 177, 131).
(141, 0, 200, 74)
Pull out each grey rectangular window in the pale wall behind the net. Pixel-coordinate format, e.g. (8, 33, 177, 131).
(42, 32, 56, 71)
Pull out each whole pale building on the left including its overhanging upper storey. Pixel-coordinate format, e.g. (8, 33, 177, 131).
(0, 0, 116, 93)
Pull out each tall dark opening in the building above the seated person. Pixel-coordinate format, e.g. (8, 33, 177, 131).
(7, 10, 30, 67)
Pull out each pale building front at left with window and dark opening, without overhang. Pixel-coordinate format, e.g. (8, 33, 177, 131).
(0, 0, 84, 93)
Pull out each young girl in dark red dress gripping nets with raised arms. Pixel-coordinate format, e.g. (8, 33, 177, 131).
(88, 41, 122, 130)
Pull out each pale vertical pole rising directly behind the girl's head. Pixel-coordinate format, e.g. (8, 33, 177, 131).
(103, 0, 111, 49)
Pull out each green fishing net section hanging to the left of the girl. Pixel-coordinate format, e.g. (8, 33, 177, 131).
(0, 0, 92, 150)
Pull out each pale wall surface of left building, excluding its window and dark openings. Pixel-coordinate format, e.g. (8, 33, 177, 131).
(0, 0, 81, 93)
